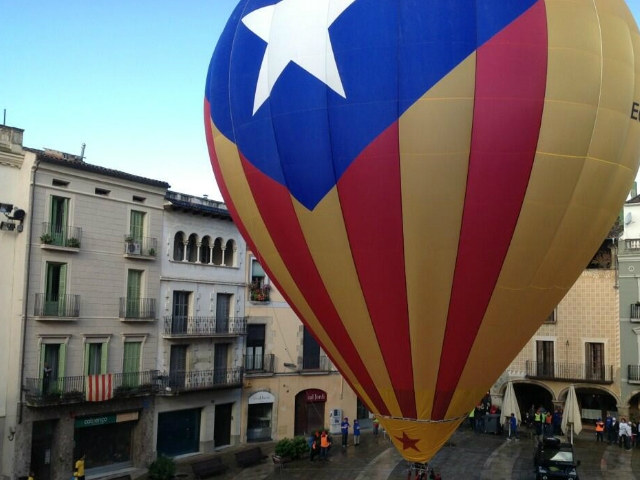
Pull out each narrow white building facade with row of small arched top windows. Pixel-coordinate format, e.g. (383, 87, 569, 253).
(155, 192, 247, 456)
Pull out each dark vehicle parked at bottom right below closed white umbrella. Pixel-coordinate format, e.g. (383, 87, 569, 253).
(533, 437, 580, 480)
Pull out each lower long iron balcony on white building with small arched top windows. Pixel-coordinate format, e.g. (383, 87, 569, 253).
(158, 368, 244, 395)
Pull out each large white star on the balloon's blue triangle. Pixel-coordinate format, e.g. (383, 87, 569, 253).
(242, 0, 356, 114)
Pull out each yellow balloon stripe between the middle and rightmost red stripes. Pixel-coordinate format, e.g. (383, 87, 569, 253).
(400, 53, 476, 418)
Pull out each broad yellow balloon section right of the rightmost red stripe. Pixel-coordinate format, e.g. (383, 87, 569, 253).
(447, 0, 640, 416)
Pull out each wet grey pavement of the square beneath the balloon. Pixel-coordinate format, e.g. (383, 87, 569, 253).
(169, 429, 640, 480)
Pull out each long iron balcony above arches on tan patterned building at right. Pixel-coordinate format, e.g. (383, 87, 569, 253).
(526, 360, 613, 384)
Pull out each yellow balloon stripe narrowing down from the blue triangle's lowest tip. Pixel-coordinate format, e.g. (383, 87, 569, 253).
(292, 191, 401, 416)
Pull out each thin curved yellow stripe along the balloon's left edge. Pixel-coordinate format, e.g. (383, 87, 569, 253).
(211, 122, 372, 405)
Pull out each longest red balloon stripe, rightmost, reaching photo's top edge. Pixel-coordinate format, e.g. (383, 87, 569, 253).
(432, 0, 548, 420)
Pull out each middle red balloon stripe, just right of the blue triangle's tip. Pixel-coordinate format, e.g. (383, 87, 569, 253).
(338, 122, 417, 418)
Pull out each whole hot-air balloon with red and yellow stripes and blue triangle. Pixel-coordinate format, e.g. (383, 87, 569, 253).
(205, 0, 640, 462)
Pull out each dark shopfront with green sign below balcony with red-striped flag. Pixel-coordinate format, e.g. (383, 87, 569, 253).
(74, 411, 140, 471)
